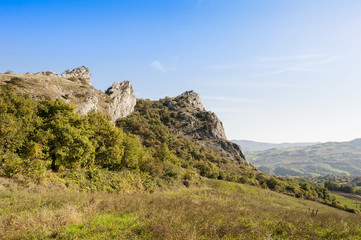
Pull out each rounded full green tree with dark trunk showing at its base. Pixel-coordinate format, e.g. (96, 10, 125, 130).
(37, 99, 95, 170)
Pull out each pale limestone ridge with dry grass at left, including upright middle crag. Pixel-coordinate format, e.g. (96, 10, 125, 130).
(0, 66, 136, 122)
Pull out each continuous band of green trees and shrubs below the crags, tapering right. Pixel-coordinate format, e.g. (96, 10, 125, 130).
(0, 85, 352, 212)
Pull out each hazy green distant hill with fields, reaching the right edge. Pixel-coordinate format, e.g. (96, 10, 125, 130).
(246, 138, 361, 176)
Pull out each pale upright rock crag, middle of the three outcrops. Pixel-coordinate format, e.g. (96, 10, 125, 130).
(105, 81, 137, 122)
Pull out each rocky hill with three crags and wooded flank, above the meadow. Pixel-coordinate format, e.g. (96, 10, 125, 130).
(0, 67, 259, 191)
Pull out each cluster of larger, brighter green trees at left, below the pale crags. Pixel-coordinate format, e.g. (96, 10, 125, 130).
(0, 85, 194, 189)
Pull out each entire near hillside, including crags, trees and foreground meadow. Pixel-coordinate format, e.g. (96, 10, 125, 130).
(0, 66, 359, 239)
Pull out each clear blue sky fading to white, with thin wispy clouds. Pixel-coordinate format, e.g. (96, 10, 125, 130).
(0, 0, 361, 142)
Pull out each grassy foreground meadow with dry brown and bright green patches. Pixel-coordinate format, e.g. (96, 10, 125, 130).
(0, 179, 361, 239)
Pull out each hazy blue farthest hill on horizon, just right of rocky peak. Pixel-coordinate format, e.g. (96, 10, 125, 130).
(232, 140, 319, 152)
